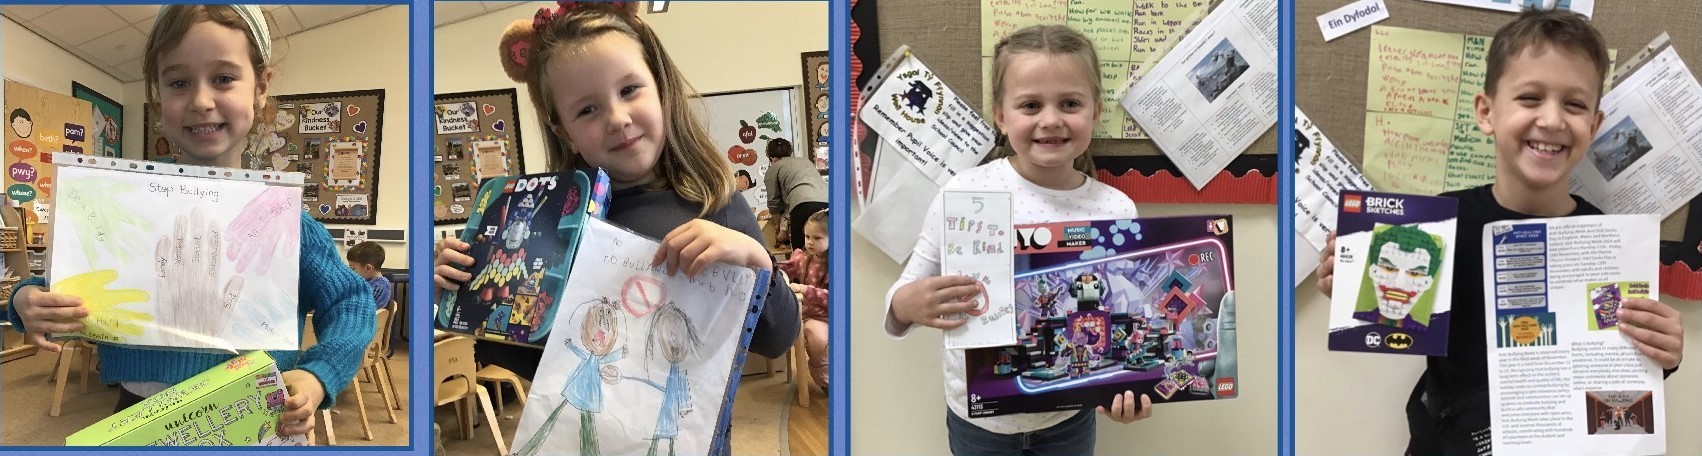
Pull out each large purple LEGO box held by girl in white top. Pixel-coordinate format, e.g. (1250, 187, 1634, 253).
(963, 216, 1239, 417)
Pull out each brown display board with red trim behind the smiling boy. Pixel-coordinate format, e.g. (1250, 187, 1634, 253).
(1294, 0, 1702, 299)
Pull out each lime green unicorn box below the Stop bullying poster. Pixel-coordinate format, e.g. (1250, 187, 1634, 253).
(65, 352, 306, 446)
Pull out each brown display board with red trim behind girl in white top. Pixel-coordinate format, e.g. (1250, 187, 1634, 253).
(864, 0, 1277, 204)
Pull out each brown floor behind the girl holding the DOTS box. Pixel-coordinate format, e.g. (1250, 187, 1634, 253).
(436, 357, 827, 456)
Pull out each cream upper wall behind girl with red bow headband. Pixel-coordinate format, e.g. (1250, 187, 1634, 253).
(434, 2, 827, 208)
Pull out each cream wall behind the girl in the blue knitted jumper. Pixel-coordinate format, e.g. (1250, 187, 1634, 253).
(112, 5, 410, 269)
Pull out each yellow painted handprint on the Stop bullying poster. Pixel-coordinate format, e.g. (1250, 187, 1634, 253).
(51, 269, 153, 342)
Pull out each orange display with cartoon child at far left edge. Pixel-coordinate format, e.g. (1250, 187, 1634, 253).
(0, 80, 94, 245)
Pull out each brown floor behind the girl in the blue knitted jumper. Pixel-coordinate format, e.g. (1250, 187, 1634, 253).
(0, 340, 408, 446)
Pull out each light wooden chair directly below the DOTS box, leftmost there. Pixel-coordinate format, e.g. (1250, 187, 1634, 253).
(432, 337, 509, 454)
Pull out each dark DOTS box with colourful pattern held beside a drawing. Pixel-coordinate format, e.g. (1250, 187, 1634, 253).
(436, 170, 609, 345)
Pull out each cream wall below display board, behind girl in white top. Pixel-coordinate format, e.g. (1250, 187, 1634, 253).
(846, 204, 1279, 454)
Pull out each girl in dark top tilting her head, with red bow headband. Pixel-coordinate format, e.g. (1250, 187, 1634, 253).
(434, 2, 798, 453)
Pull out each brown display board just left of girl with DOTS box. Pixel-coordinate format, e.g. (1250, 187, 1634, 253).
(432, 88, 526, 225)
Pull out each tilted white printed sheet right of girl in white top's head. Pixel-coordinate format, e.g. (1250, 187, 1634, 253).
(1120, 0, 1277, 189)
